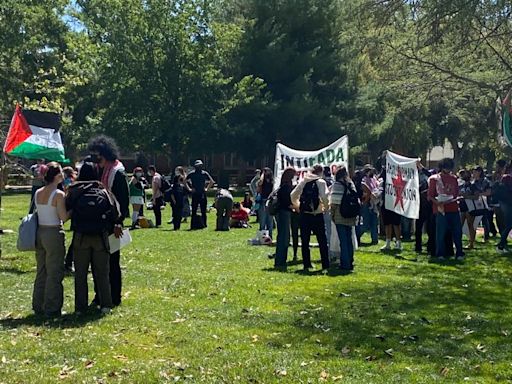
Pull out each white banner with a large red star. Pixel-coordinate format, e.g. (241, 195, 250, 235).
(384, 151, 420, 219)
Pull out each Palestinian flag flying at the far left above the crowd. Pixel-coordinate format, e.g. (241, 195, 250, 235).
(4, 106, 66, 162)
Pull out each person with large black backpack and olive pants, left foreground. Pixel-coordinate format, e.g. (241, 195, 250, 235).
(66, 161, 120, 315)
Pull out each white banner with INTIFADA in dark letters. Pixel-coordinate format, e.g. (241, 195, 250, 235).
(274, 136, 348, 188)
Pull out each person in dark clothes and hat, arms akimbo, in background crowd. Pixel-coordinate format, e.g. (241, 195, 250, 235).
(187, 160, 215, 229)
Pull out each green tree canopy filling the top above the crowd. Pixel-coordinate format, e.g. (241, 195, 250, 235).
(0, 0, 512, 164)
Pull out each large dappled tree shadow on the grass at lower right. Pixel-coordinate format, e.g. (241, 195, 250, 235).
(284, 270, 511, 364)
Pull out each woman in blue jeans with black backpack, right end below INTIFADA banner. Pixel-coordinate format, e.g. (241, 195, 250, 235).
(329, 167, 361, 271)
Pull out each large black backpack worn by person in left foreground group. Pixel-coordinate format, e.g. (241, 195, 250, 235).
(71, 183, 120, 235)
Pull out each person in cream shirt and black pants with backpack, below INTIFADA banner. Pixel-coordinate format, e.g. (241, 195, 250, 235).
(290, 164, 329, 271)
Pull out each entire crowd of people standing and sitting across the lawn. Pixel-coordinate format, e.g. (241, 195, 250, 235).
(21, 136, 512, 316)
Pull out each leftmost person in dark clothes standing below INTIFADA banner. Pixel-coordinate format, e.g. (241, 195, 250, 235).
(274, 168, 297, 271)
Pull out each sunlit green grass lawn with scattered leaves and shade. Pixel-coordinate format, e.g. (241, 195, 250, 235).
(0, 195, 512, 384)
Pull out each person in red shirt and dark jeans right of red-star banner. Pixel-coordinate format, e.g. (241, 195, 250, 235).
(428, 158, 464, 260)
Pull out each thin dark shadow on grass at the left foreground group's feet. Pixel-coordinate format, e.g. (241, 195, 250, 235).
(0, 312, 105, 329)
